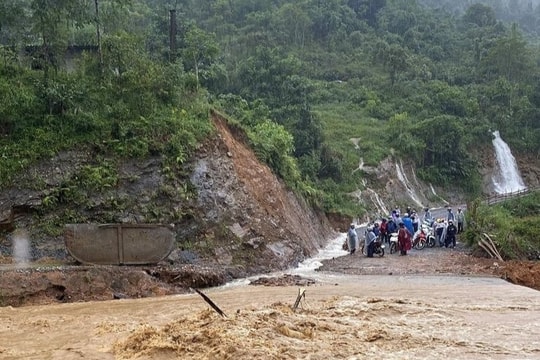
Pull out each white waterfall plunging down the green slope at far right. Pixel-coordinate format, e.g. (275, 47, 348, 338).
(493, 130, 527, 194)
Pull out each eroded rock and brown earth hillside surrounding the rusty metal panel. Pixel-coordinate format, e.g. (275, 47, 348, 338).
(0, 115, 333, 305)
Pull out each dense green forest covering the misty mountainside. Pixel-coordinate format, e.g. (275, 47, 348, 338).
(0, 0, 540, 219)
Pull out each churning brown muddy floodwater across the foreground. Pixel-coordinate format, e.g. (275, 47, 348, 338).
(0, 275, 540, 360)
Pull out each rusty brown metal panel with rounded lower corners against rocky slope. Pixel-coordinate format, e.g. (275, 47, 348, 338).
(65, 224, 174, 265)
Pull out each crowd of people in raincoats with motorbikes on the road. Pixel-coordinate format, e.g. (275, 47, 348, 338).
(347, 207, 465, 257)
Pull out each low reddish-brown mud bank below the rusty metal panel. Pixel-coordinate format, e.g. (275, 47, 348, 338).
(0, 264, 239, 307)
